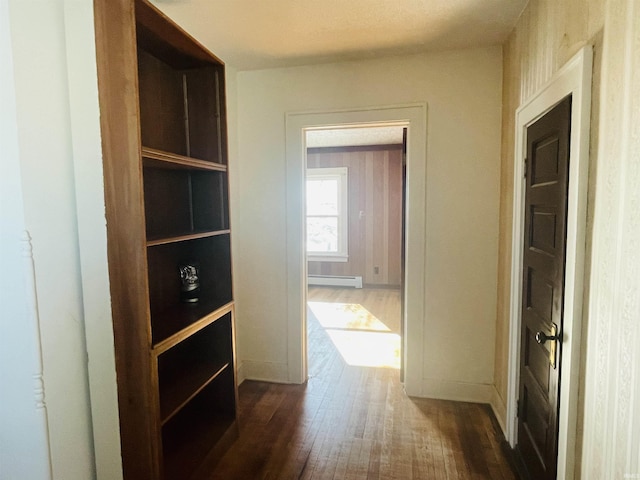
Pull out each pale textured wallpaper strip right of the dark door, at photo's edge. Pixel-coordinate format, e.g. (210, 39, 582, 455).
(582, 0, 640, 479)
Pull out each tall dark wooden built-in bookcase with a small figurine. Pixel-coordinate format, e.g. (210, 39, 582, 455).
(95, 0, 237, 480)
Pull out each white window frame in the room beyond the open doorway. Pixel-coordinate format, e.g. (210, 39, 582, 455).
(305, 167, 349, 262)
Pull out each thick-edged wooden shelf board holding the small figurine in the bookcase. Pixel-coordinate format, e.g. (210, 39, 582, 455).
(153, 302, 233, 356)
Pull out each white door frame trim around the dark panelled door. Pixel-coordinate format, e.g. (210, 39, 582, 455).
(506, 45, 593, 480)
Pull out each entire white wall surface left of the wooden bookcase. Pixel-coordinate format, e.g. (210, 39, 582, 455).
(0, 0, 116, 480)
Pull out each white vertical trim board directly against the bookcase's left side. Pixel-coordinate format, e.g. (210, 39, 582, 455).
(64, 0, 122, 480)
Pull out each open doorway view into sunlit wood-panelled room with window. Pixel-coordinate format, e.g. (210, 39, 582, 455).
(303, 124, 406, 376)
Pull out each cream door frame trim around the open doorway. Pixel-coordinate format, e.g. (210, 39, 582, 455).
(286, 103, 427, 395)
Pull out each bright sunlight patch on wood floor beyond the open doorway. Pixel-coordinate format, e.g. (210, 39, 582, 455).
(309, 302, 400, 369)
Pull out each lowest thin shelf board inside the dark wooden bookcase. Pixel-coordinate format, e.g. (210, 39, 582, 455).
(160, 363, 230, 425)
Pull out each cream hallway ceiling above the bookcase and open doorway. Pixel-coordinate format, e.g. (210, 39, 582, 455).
(153, 0, 528, 70)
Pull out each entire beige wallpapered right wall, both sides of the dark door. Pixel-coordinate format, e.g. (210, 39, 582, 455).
(495, 0, 640, 480)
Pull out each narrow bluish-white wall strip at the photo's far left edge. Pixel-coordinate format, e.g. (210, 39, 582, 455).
(0, 0, 51, 479)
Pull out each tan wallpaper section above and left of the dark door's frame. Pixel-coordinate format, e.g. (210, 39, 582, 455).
(495, 0, 604, 412)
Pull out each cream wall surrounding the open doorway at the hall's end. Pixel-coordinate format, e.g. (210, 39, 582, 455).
(233, 47, 502, 401)
